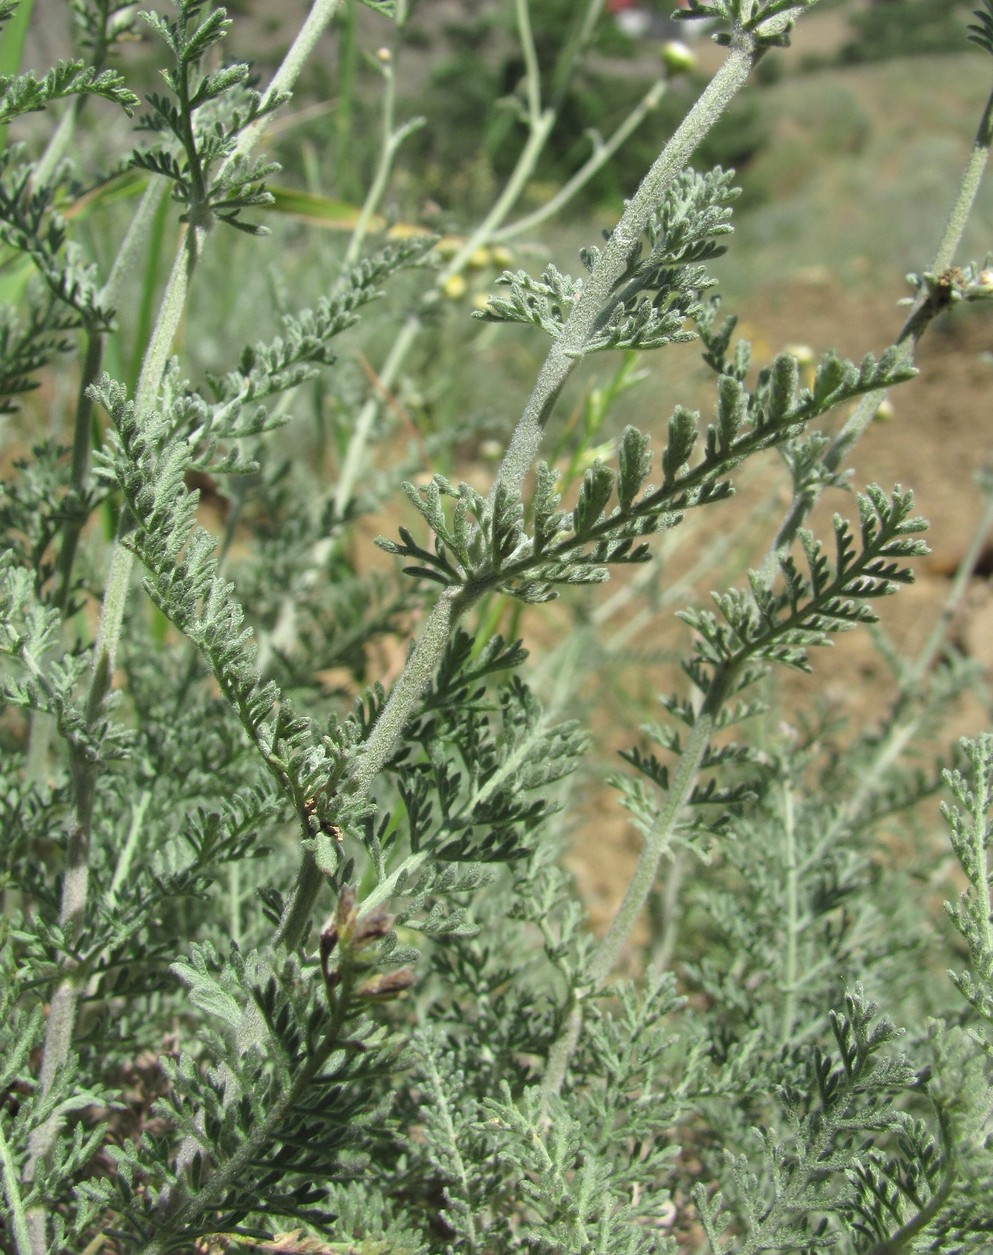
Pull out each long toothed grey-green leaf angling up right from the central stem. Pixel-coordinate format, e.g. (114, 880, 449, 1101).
(377, 350, 923, 604)
